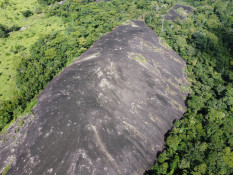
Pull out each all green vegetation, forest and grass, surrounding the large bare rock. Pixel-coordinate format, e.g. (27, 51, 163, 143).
(0, 0, 233, 175)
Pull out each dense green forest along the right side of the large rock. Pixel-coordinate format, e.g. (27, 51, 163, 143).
(146, 0, 233, 174)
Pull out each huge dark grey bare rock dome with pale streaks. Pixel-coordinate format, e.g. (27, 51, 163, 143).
(0, 21, 187, 175)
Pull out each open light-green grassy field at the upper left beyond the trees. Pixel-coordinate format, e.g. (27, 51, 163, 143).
(0, 0, 65, 100)
